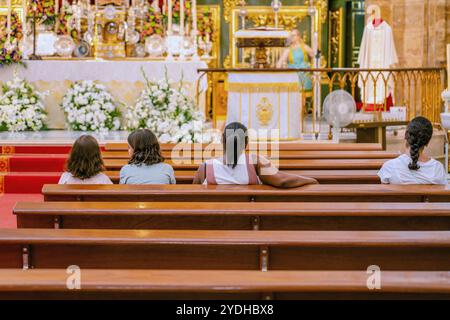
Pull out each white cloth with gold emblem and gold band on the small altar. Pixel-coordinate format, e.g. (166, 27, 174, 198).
(227, 72, 302, 140)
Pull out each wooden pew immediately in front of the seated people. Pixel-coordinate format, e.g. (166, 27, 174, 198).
(105, 170, 381, 184)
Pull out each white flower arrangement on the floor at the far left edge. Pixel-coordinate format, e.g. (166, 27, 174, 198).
(0, 76, 47, 131)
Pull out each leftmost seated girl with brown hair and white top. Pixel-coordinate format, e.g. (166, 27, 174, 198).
(59, 135, 112, 184)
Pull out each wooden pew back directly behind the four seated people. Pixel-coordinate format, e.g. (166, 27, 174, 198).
(42, 184, 450, 202)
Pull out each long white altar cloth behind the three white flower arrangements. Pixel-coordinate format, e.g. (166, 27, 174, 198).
(0, 60, 208, 129)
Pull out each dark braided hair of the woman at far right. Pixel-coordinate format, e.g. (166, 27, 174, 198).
(405, 117, 433, 170)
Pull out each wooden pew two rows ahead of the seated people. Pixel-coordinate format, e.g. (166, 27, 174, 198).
(104, 159, 389, 171)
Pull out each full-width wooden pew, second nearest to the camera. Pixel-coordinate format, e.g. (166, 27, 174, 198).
(0, 229, 450, 271)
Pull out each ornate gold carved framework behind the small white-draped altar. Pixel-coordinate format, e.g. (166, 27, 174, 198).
(224, 5, 322, 68)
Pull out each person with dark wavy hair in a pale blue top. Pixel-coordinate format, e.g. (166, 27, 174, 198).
(120, 129, 176, 184)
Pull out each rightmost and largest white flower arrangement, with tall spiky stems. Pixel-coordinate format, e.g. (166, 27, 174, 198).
(125, 72, 204, 143)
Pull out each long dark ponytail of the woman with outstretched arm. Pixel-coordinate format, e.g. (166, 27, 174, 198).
(222, 122, 248, 169)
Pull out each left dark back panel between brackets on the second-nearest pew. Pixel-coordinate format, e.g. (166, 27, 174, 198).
(32, 244, 259, 270)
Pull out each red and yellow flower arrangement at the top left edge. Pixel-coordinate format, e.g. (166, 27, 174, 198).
(0, 11, 23, 66)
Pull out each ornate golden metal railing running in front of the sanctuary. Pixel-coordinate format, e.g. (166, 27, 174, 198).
(199, 68, 446, 129)
